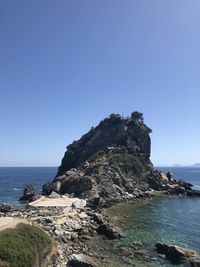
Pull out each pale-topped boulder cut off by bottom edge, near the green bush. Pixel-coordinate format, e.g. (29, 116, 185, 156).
(67, 254, 97, 267)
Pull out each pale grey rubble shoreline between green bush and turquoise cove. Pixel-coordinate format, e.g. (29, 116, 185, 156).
(0, 196, 128, 267)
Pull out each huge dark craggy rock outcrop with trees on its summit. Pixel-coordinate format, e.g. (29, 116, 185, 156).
(43, 112, 162, 205)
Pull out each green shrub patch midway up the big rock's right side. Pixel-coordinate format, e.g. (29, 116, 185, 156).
(109, 153, 142, 174)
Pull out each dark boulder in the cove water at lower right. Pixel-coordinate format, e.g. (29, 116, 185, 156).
(156, 242, 196, 263)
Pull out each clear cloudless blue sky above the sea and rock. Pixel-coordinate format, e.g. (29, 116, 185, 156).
(0, 0, 200, 166)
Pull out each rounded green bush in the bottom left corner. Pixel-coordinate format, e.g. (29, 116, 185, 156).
(0, 224, 52, 267)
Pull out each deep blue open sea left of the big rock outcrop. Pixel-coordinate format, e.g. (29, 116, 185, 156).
(0, 167, 57, 208)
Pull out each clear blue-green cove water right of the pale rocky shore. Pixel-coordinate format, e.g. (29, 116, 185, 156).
(103, 197, 200, 266)
